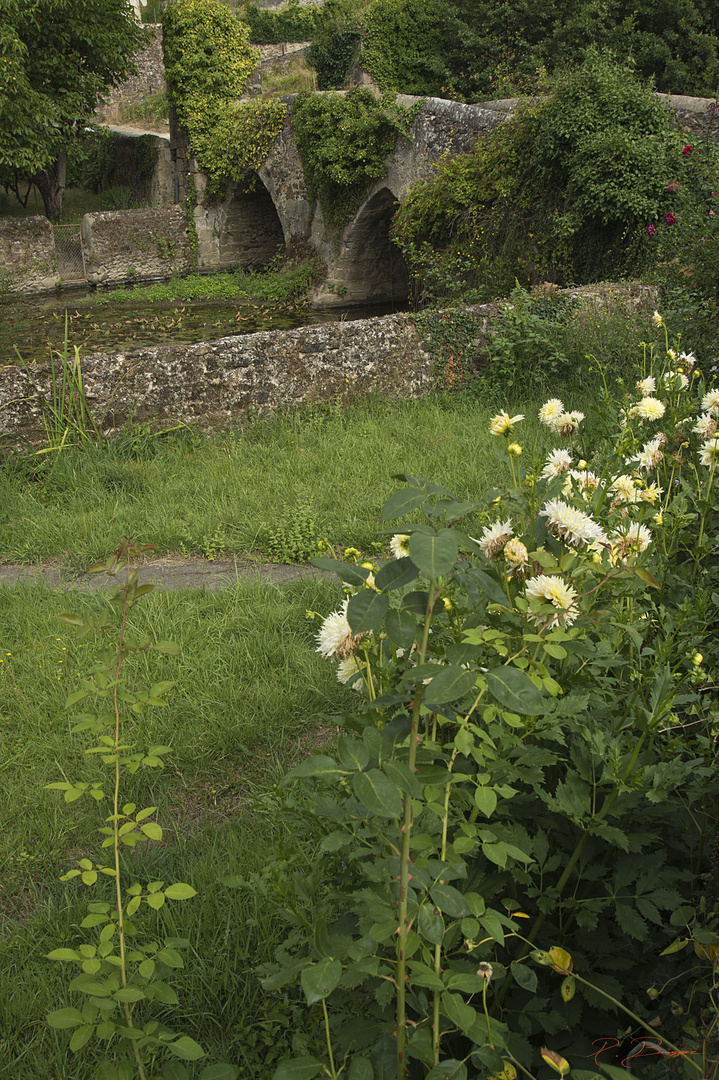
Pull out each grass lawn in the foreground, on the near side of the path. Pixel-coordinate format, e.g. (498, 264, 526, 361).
(0, 580, 351, 1080)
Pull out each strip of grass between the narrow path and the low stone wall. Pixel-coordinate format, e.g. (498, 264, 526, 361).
(0, 397, 561, 570)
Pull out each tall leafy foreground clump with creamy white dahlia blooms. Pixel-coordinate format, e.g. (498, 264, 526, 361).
(241, 314, 719, 1080)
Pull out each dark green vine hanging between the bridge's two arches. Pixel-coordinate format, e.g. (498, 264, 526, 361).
(293, 87, 419, 239)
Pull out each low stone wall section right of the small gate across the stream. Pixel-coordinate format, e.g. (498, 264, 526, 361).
(82, 206, 193, 285)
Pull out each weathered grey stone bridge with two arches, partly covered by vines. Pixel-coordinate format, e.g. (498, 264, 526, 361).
(179, 96, 516, 307)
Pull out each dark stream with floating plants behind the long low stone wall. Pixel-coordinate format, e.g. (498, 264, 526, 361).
(0, 287, 402, 364)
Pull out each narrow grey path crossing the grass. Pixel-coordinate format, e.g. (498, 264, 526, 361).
(0, 556, 334, 592)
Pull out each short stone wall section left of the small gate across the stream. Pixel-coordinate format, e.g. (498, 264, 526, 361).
(0, 216, 58, 293)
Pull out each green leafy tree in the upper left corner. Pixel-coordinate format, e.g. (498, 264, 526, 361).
(0, 0, 145, 217)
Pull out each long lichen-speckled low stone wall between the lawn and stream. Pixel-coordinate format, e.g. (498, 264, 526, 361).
(0, 314, 431, 443)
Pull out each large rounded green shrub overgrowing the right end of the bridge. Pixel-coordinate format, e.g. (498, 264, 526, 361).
(394, 53, 681, 299)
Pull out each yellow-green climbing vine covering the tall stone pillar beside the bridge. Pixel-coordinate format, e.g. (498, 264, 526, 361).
(162, 0, 287, 194)
